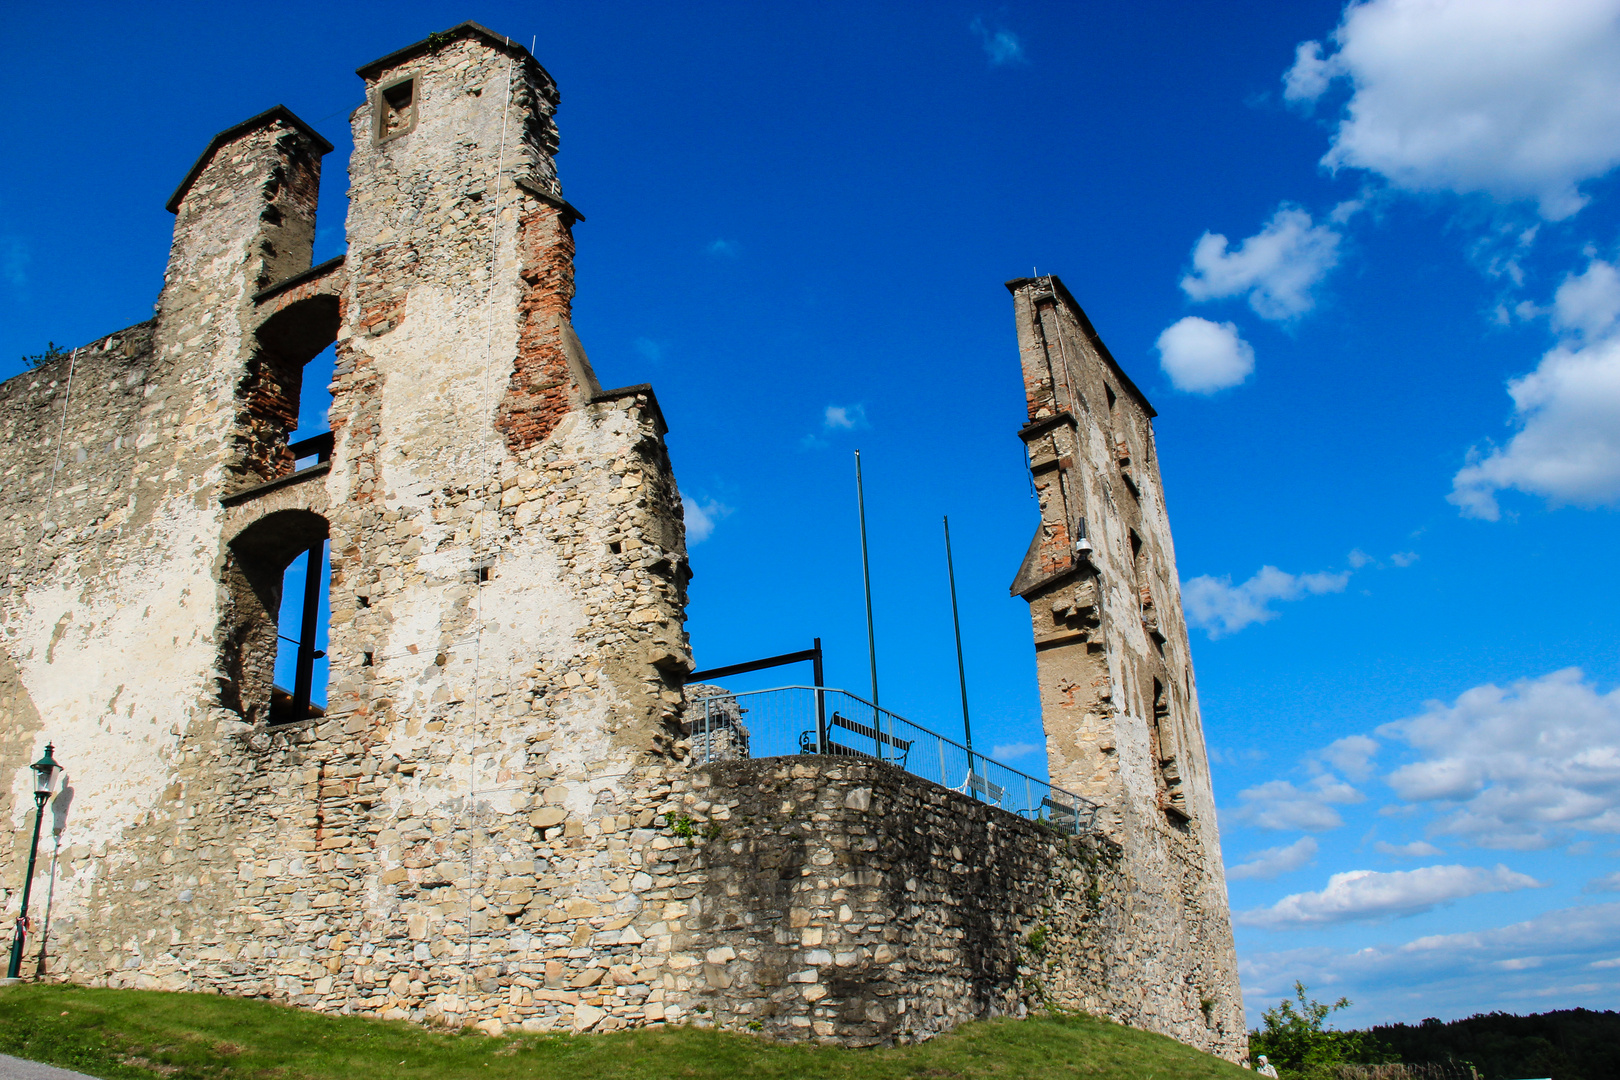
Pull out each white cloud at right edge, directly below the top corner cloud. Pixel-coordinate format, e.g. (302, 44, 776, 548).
(1450, 259, 1620, 521)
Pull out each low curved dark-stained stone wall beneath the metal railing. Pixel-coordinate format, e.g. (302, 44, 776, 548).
(666, 756, 1244, 1056)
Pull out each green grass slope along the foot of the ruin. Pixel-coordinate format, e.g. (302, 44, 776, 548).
(0, 984, 1254, 1080)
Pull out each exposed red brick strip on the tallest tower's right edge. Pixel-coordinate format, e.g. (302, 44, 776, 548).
(497, 193, 588, 452)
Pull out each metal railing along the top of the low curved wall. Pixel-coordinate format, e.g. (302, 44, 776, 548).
(687, 687, 1097, 834)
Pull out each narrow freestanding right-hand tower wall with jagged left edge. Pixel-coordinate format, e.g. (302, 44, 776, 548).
(1008, 277, 1244, 1041)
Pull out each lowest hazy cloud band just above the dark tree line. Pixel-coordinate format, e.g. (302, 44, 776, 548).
(1239, 904, 1620, 1027)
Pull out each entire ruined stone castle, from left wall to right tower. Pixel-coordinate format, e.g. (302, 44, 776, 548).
(0, 23, 1244, 1057)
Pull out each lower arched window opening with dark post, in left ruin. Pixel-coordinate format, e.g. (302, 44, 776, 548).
(220, 510, 330, 725)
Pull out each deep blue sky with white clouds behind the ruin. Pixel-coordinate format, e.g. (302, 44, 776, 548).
(0, 0, 1620, 1023)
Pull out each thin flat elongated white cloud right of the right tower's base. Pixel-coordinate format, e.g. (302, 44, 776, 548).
(1234, 863, 1541, 929)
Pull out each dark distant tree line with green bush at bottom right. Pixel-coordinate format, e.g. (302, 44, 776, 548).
(1249, 983, 1620, 1080)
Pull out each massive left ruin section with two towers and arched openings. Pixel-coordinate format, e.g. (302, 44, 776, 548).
(0, 23, 690, 1027)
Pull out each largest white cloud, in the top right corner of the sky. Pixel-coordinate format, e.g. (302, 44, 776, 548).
(1283, 0, 1620, 220)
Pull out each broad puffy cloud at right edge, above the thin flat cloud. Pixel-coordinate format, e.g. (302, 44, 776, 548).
(1377, 667, 1620, 850)
